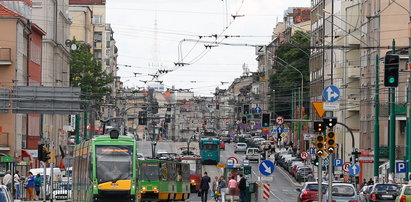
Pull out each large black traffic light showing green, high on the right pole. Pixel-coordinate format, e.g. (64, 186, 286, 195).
(384, 54, 400, 87)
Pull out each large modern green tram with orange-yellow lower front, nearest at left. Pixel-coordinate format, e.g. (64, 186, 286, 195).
(72, 134, 138, 202)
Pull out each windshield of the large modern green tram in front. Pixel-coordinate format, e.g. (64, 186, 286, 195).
(96, 145, 133, 183)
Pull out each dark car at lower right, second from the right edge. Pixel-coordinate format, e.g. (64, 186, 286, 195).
(369, 184, 401, 202)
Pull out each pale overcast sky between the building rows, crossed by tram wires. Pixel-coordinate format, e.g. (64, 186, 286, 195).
(106, 0, 310, 96)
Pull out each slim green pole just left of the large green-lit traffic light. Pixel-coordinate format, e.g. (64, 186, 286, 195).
(374, 54, 382, 183)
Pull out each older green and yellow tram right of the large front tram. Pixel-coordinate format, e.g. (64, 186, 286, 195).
(138, 159, 190, 201)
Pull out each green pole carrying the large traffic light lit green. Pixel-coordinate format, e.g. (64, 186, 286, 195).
(388, 39, 395, 182)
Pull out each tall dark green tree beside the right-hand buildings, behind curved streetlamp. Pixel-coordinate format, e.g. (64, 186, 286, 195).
(269, 31, 310, 118)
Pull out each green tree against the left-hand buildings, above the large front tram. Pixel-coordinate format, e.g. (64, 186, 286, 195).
(70, 39, 114, 102)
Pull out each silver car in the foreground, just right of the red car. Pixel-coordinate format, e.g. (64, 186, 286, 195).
(323, 183, 360, 202)
